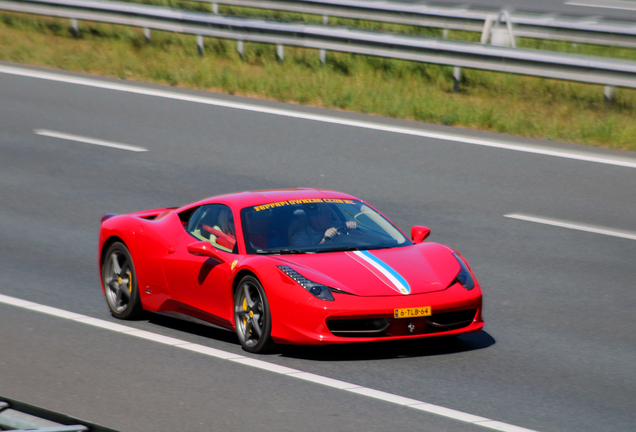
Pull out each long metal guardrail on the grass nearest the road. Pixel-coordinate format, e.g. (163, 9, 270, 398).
(0, 0, 636, 97)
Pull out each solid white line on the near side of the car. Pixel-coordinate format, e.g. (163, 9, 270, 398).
(0, 294, 536, 432)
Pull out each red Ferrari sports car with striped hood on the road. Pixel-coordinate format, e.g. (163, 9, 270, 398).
(99, 189, 484, 353)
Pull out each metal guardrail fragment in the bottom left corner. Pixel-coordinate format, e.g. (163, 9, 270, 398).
(0, 396, 117, 432)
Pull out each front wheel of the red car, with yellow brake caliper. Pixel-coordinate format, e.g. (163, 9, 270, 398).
(234, 276, 274, 354)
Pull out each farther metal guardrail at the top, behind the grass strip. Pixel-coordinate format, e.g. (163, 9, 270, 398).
(207, 0, 636, 48)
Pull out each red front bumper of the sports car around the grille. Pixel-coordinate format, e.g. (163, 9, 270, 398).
(268, 283, 484, 345)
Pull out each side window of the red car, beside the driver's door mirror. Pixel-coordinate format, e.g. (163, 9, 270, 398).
(187, 204, 238, 253)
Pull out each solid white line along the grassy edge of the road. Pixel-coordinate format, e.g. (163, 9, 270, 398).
(0, 65, 636, 168)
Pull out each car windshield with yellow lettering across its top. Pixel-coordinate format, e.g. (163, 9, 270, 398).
(241, 198, 412, 254)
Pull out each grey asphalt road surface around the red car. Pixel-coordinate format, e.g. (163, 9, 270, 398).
(0, 61, 636, 432)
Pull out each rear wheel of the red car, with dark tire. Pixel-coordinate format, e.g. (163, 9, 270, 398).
(102, 242, 143, 319)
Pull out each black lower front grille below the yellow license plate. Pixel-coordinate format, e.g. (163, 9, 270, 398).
(327, 309, 477, 337)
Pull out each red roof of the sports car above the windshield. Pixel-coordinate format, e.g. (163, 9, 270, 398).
(177, 188, 358, 211)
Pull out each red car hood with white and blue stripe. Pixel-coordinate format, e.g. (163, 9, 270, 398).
(271, 243, 460, 296)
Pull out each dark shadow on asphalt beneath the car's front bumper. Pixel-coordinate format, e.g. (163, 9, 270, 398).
(276, 330, 496, 361)
